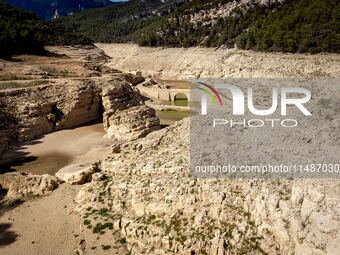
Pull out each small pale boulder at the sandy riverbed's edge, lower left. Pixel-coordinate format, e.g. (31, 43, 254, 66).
(55, 162, 100, 185)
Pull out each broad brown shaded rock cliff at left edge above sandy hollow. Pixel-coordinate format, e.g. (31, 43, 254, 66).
(0, 81, 101, 142)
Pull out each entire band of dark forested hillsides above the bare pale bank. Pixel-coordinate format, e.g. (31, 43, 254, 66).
(0, 0, 340, 57)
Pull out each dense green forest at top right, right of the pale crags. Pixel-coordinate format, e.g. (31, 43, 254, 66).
(237, 0, 340, 53)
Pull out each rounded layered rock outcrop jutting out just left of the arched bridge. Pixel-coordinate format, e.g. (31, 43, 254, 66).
(102, 83, 159, 142)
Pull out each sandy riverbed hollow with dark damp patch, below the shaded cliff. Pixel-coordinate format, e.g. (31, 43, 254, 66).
(0, 123, 111, 175)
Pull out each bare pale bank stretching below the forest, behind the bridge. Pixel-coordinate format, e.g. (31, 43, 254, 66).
(97, 44, 340, 79)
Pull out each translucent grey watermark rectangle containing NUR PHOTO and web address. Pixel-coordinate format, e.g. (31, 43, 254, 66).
(188, 78, 340, 179)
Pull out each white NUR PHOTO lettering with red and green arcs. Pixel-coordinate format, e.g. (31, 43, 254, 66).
(194, 81, 312, 128)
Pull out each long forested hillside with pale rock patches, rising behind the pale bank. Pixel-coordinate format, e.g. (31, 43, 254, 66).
(60, 0, 340, 53)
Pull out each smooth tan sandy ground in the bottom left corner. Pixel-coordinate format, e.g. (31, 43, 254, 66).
(0, 184, 80, 255)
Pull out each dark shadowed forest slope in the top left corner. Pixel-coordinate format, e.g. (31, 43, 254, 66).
(0, 1, 92, 58)
